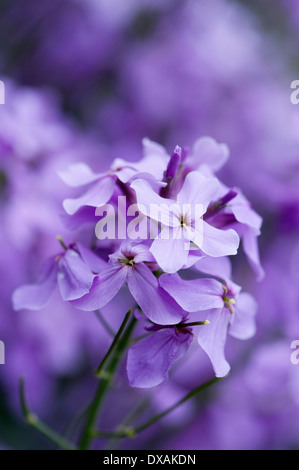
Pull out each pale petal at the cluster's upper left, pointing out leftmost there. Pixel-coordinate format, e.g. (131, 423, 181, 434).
(63, 176, 116, 215)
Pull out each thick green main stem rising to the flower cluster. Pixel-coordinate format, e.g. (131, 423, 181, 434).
(79, 310, 136, 450)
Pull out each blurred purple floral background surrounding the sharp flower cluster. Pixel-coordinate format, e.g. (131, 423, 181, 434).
(0, 0, 299, 449)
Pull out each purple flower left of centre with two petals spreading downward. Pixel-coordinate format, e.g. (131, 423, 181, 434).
(72, 243, 185, 325)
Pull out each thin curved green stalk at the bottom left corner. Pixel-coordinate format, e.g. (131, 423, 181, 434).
(20, 378, 76, 450)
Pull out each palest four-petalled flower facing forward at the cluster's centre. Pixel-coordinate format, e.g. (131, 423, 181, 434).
(131, 171, 239, 273)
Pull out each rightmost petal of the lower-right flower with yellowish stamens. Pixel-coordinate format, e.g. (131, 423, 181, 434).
(229, 292, 257, 340)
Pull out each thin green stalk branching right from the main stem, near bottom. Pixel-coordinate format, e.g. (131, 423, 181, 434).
(95, 377, 223, 439)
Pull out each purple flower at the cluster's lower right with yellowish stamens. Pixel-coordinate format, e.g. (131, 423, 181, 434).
(159, 274, 257, 377)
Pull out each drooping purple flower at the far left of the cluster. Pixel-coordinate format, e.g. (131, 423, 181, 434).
(13, 243, 105, 310)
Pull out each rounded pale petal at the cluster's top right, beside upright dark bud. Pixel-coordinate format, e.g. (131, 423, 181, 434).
(192, 137, 229, 171)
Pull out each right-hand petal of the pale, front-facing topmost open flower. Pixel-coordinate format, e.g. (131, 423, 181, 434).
(200, 221, 240, 258)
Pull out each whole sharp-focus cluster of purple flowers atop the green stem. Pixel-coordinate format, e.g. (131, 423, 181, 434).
(13, 137, 263, 388)
